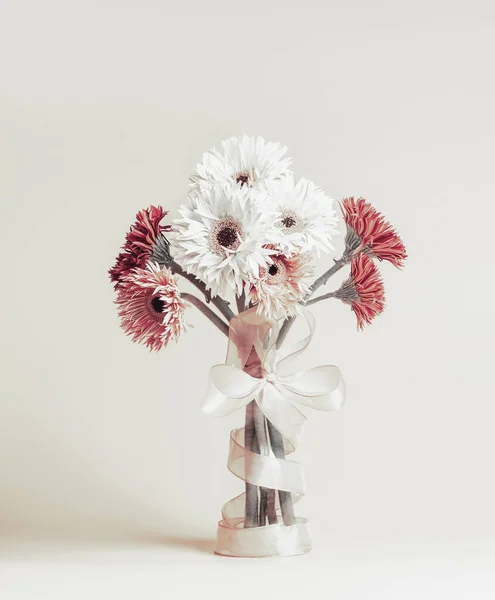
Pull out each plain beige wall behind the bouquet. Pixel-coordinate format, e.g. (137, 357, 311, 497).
(0, 0, 495, 600)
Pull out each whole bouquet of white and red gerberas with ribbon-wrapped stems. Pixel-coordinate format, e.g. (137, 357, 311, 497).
(109, 136, 406, 557)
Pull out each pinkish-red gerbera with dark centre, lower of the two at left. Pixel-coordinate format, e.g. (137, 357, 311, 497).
(115, 264, 186, 351)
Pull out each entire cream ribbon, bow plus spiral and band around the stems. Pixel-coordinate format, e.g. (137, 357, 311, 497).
(202, 309, 345, 557)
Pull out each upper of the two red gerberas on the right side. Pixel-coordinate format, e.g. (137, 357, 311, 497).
(341, 198, 407, 268)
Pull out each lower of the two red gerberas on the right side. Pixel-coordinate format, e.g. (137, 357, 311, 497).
(332, 254, 385, 329)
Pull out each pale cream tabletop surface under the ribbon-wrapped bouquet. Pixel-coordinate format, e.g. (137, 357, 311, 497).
(0, 537, 495, 600)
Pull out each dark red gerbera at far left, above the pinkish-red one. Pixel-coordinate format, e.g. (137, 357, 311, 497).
(108, 206, 172, 290)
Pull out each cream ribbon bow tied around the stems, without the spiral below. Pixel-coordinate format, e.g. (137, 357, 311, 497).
(202, 309, 345, 448)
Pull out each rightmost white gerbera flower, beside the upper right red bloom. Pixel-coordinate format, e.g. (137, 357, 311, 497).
(269, 177, 338, 256)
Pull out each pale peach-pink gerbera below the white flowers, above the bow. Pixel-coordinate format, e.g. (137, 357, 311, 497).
(248, 248, 313, 319)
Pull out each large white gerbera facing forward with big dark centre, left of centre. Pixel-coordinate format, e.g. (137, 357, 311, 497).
(172, 183, 272, 296)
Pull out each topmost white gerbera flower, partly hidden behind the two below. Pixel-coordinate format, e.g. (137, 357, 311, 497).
(190, 135, 292, 189)
